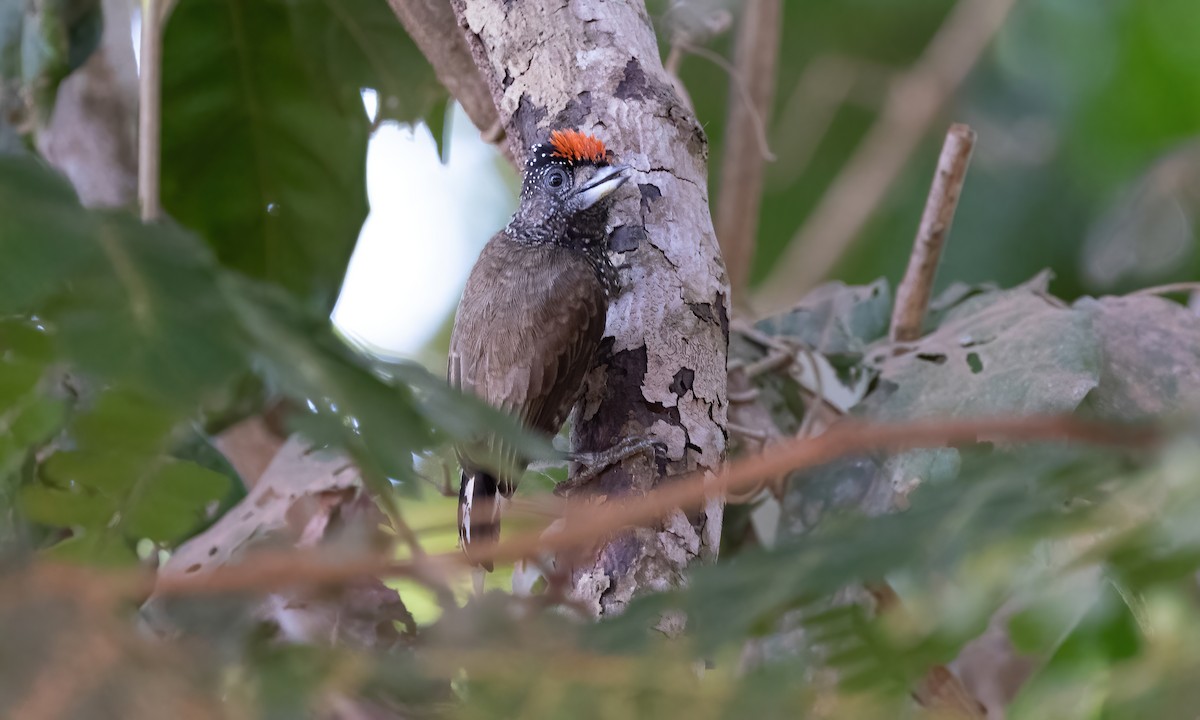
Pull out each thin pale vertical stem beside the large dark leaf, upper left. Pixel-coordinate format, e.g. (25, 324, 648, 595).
(138, 0, 163, 222)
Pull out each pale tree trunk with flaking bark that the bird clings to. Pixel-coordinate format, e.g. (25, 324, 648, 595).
(451, 0, 728, 614)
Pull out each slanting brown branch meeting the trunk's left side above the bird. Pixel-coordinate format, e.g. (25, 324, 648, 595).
(388, 0, 517, 164)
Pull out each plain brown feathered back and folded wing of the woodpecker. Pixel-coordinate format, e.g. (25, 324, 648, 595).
(448, 236, 607, 491)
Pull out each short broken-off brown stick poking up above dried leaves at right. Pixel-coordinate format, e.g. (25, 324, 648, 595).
(892, 124, 976, 342)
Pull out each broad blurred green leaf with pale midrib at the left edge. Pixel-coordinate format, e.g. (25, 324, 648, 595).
(0, 157, 245, 407)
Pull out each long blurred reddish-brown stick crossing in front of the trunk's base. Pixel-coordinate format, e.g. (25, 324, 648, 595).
(145, 416, 1159, 595)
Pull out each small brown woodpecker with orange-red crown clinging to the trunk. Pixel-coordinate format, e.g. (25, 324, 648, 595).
(448, 128, 630, 571)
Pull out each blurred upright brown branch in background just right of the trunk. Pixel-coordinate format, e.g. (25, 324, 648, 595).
(716, 0, 782, 298)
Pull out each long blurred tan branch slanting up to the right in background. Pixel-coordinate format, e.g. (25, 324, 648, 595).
(755, 0, 1015, 316)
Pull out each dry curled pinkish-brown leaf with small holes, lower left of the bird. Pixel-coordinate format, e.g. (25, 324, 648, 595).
(145, 436, 434, 647)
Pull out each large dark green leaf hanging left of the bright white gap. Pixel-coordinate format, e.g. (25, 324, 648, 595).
(162, 0, 369, 312)
